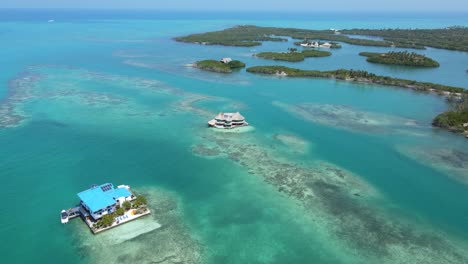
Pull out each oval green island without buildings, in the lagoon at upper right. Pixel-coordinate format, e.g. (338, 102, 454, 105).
(359, 51, 440, 67)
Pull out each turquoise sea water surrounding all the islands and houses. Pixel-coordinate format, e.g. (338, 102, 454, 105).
(0, 10, 468, 263)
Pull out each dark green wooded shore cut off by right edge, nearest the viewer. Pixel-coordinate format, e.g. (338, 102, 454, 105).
(432, 94, 468, 135)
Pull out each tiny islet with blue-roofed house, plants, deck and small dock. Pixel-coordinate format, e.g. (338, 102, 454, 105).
(60, 183, 151, 234)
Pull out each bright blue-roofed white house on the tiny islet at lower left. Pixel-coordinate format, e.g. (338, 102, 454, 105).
(78, 183, 134, 220)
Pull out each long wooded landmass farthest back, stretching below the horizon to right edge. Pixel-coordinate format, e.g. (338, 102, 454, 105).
(175, 25, 468, 51)
